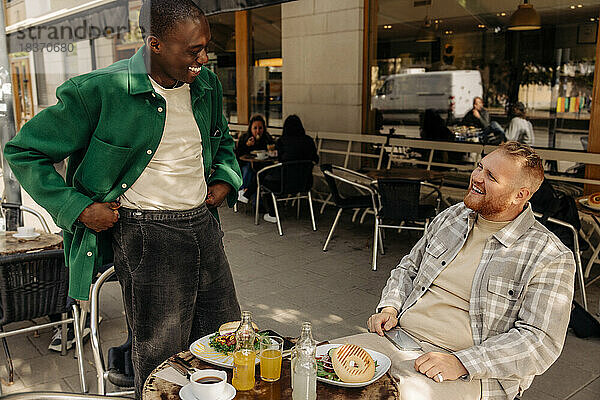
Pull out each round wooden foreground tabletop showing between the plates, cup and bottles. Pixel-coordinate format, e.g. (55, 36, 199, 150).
(142, 351, 400, 400)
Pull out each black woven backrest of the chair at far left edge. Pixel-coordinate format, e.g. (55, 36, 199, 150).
(0, 250, 69, 326)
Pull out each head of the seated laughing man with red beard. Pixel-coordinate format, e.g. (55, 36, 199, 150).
(464, 150, 529, 221)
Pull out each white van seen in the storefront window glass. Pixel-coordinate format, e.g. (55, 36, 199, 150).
(371, 70, 483, 128)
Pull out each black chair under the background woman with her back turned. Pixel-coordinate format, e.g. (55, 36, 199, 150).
(254, 160, 317, 236)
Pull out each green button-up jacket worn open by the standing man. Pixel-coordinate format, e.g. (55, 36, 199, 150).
(4, 47, 241, 300)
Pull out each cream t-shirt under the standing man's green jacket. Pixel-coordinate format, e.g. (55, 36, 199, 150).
(121, 77, 207, 210)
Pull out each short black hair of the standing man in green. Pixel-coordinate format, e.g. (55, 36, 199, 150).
(139, 0, 204, 39)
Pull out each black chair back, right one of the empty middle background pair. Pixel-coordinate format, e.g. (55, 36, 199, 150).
(377, 178, 421, 222)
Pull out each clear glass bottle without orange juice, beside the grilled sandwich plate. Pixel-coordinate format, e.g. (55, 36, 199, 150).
(292, 322, 317, 400)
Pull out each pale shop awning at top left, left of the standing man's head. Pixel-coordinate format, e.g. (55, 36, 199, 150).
(6, 0, 129, 53)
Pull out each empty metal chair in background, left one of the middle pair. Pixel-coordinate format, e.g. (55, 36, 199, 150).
(321, 164, 377, 251)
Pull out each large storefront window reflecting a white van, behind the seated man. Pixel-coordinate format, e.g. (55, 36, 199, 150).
(371, 0, 600, 150)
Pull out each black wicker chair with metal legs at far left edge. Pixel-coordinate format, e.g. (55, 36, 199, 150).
(0, 250, 87, 392)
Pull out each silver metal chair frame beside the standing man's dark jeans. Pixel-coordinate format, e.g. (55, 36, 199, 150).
(90, 266, 135, 396)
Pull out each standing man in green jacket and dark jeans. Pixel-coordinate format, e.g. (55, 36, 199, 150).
(4, 0, 241, 398)
